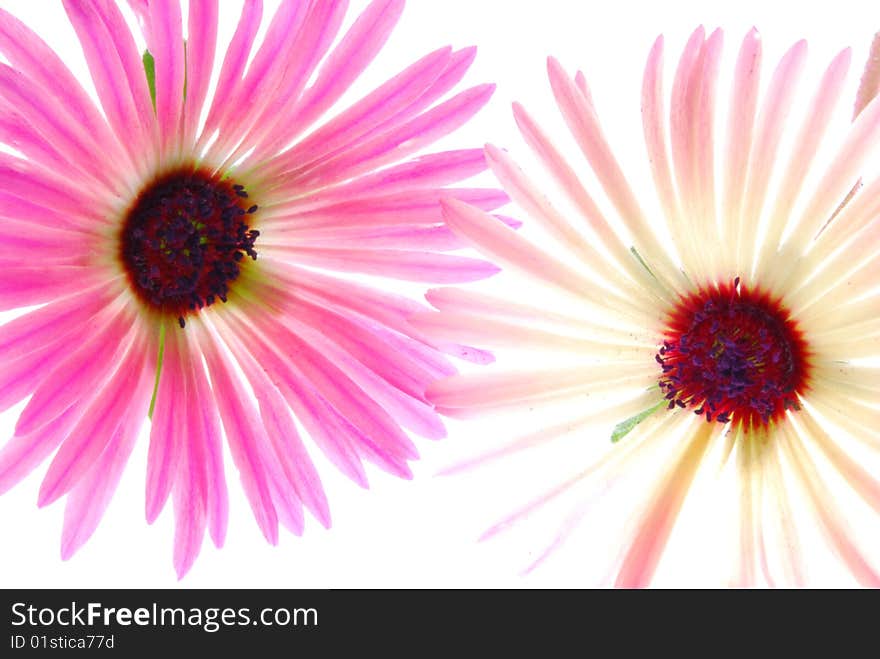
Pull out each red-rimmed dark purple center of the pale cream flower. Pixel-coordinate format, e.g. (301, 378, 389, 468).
(656, 279, 809, 431)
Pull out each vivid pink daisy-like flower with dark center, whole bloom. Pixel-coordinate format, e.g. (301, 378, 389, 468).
(0, 0, 506, 576)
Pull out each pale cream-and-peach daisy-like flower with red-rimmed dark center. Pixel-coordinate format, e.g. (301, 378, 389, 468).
(412, 28, 880, 586)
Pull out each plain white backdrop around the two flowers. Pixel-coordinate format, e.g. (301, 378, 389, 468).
(0, 0, 880, 588)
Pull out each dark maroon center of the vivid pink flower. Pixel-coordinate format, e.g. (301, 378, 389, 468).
(122, 169, 260, 327)
